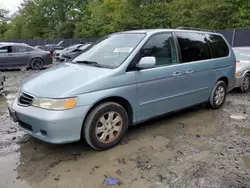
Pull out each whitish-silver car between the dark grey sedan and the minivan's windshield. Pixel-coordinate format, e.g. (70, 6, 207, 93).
(54, 44, 84, 61)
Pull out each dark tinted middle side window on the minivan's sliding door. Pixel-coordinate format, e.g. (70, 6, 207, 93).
(175, 32, 212, 63)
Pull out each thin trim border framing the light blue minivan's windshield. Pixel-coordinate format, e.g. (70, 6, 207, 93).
(72, 32, 147, 69)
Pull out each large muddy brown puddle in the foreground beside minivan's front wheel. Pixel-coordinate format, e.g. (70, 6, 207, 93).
(17, 136, 173, 188)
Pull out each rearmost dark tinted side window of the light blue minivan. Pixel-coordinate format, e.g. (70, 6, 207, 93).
(207, 34, 229, 58)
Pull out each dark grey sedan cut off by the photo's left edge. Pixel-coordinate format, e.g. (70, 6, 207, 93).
(0, 43, 53, 70)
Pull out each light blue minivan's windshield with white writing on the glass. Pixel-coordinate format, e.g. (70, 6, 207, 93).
(73, 33, 145, 68)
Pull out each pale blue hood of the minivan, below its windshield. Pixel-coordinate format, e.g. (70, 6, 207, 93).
(21, 63, 112, 98)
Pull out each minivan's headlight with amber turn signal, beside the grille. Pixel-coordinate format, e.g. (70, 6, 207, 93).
(32, 97, 77, 110)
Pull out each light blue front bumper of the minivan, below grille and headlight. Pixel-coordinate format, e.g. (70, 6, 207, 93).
(10, 99, 90, 144)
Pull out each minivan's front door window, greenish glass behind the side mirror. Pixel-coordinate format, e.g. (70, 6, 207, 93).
(141, 33, 177, 66)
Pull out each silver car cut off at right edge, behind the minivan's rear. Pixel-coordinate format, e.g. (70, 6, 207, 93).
(233, 47, 250, 93)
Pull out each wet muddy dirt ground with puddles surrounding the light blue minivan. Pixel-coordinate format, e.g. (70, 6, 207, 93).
(0, 71, 250, 188)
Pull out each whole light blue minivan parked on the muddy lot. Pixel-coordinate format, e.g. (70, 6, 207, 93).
(9, 29, 236, 150)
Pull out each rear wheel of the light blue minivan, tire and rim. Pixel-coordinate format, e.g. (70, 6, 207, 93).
(207, 81, 227, 109)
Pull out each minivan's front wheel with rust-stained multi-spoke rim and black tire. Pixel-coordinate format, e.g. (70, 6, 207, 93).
(82, 102, 129, 150)
